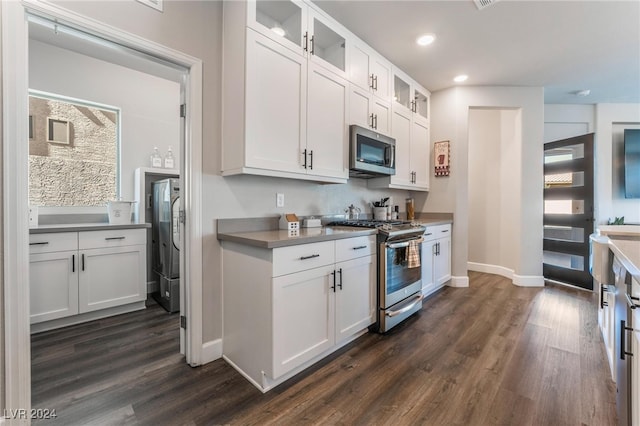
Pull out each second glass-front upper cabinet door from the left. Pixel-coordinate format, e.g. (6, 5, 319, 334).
(308, 11, 347, 78)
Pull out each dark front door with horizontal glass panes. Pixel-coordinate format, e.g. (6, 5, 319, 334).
(543, 133, 594, 290)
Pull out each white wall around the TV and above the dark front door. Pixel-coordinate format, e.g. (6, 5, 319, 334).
(544, 104, 640, 225)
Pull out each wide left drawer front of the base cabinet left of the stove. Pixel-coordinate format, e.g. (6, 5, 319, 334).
(273, 241, 335, 277)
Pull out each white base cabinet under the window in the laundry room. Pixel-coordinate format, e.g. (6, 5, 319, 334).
(29, 229, 147, 325)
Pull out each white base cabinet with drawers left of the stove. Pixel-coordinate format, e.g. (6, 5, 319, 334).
(223, 236, 376, 391)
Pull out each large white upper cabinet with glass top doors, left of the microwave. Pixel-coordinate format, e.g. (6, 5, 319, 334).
(222, 1, 349, 183)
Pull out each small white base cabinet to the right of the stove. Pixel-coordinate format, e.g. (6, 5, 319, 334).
(421, 224, 451, 296)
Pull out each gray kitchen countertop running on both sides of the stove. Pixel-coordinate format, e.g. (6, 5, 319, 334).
(218, 218, 452, 249)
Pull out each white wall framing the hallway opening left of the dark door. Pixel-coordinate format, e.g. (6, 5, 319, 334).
(420, 87, 544, 285)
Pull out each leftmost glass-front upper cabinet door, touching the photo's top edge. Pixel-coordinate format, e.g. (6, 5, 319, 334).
(247, 0, 307, 54)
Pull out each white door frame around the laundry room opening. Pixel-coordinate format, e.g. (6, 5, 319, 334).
(0, 0, 203, 412)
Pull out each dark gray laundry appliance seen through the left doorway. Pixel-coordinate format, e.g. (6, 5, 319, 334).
(151, 178, 180, 312)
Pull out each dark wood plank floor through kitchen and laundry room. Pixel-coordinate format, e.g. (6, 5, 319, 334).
(32, 273, 616, 426)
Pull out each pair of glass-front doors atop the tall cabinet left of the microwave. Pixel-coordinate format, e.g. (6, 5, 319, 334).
(247, 0, 347, 78)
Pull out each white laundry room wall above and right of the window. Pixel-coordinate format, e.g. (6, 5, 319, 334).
(29, 40, 180, 206)
